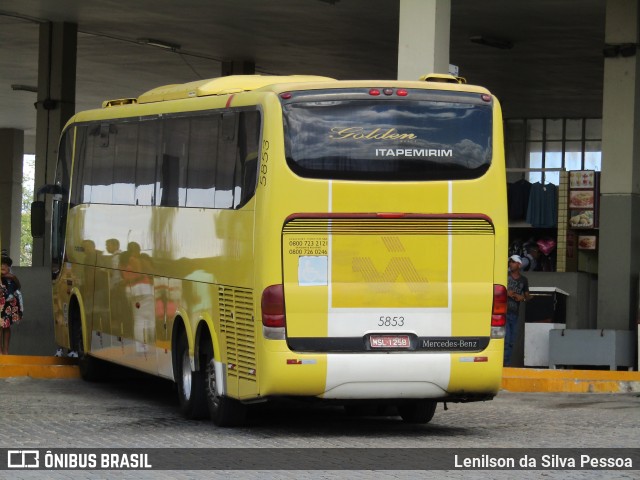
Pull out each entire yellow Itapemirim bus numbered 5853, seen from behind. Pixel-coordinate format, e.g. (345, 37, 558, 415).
(36, 75, 507, 426)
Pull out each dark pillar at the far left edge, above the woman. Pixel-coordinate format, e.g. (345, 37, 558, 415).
(0, 128, 24, 266)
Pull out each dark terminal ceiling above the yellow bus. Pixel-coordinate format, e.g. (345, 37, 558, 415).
(0, 0, 605, 153)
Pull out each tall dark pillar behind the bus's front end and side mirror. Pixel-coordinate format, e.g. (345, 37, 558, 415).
(33, 23, 78, 266)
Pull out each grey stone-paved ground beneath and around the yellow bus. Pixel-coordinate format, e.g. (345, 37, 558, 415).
(0, 376, 640, 480)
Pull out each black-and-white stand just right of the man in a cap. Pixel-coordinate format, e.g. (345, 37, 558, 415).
(524, 287, 569, 367)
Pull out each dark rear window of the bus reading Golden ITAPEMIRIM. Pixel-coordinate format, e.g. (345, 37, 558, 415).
(283, 99, 492, 181)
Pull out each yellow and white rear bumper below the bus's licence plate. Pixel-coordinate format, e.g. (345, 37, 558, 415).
(260, 341, 502, 402)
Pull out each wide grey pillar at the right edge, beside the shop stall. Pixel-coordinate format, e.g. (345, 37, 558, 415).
(597, 0, 640, 330)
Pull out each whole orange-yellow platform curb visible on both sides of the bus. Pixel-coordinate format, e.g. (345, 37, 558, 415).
(0, 355, 640, 393)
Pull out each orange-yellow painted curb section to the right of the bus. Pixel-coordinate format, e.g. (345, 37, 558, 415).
(502, 368, 640, 393)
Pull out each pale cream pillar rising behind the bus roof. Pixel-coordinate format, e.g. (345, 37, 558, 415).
(398, 0, 451, 80)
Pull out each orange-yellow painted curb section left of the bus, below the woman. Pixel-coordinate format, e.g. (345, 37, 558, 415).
(0, 355, 80, 378)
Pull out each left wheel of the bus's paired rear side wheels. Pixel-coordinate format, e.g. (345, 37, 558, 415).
(175, 333, 207, 419)
